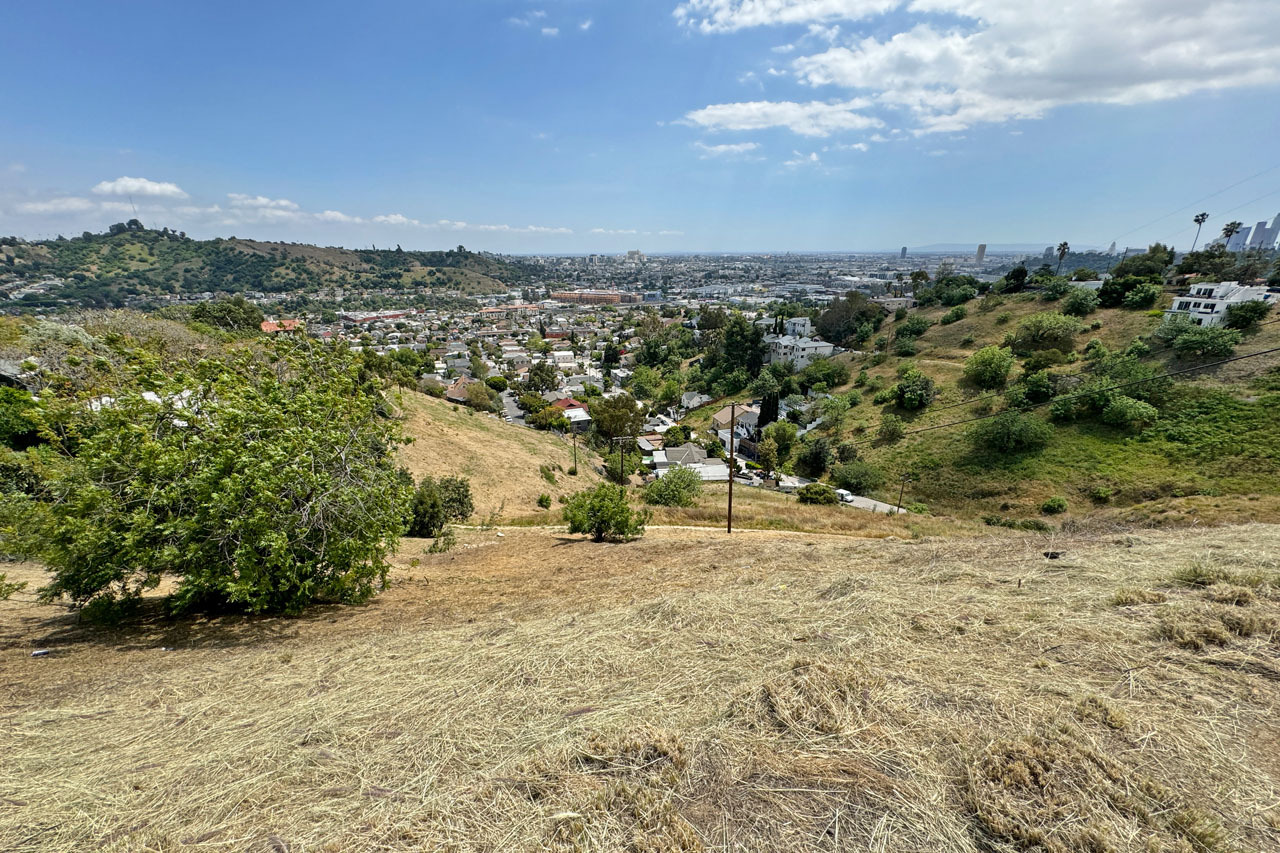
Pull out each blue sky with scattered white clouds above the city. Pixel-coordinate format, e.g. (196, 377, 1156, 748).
(0, 0, 1280, 254)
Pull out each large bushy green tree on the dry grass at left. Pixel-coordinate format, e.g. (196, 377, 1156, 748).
(4, 341, 412, 612)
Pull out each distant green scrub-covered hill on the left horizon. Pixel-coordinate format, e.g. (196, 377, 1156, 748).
(0, 229, 522, 307)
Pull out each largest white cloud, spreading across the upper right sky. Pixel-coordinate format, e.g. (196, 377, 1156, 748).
(675, 0, 1280, 136)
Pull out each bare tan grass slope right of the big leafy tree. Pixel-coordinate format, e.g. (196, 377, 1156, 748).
(401, 391, 600, 521)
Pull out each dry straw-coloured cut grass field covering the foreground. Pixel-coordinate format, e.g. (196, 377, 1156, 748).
(0, 524, 1280, 853)
